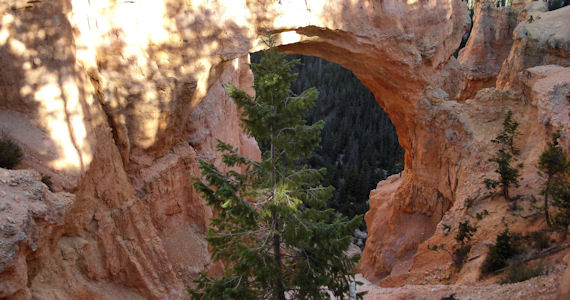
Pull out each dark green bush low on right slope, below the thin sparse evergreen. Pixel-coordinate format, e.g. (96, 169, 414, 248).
(481, 228, 518, 274)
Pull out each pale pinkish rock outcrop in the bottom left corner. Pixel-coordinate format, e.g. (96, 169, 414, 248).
(0, 168, 75, 299)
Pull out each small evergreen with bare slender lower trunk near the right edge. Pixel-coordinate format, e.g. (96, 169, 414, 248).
(538, 130, 570, 227)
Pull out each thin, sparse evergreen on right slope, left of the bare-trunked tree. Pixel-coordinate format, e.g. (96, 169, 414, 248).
(484, 110, 522, 208)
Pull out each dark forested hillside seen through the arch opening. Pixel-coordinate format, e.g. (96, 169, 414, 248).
(251, 54, 403, 221)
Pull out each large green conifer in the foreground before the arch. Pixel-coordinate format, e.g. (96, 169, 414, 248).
(191, 40, 362, 299)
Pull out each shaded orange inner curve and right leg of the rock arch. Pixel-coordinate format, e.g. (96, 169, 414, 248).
(254, 32, 468, 283)
